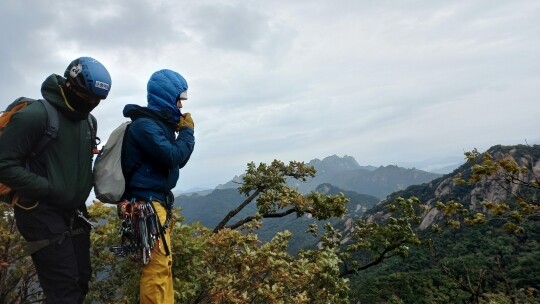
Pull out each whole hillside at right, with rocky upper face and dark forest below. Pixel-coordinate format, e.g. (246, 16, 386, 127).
(351, 145, 540, 303)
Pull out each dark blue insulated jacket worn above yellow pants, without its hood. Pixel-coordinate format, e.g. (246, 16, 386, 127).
(122, 105, 195, 201)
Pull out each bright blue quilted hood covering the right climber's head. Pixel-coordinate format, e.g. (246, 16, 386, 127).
(147, 69, 188, 124)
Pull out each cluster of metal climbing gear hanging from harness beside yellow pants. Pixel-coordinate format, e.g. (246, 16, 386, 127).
(111, 199, 161, 265)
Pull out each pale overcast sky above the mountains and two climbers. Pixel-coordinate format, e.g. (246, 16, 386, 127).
(0, 0, 540, 190)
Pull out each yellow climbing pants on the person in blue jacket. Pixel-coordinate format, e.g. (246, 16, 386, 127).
(140, 201, 174, 304)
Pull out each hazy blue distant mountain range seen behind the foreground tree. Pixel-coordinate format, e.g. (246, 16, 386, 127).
(175, 155, 440, 252)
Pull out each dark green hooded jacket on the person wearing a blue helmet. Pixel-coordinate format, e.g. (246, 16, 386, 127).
(0, 74, 97, 209)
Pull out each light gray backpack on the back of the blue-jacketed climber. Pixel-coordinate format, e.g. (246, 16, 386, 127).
(94, 121, 131, 204)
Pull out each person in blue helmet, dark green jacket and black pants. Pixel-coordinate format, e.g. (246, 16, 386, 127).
(0, 57, 111, 304)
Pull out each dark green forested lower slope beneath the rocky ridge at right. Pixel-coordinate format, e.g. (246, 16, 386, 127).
(350, 220, 540, 304)
